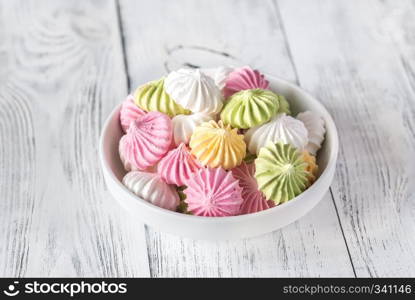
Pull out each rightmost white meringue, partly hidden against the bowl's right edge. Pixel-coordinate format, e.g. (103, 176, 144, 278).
(297, 111, 326, 155)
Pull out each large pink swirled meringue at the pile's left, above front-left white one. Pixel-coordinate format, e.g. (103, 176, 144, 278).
(119, 112, 173, 171)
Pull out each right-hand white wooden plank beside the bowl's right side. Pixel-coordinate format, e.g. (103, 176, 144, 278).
(278, 0, 415, 277)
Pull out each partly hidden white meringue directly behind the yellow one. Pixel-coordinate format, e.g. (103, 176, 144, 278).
(172, 113, 212, 145)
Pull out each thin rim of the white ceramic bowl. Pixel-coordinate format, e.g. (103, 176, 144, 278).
(99, 74, 339, 223)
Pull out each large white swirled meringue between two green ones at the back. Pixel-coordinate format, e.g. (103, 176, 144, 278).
(164, 69, 223, 114)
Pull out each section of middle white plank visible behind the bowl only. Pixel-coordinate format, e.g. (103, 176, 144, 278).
(120, 0, 295, 87)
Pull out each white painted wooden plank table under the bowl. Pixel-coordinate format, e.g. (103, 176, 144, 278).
(0, 0, 415, 277)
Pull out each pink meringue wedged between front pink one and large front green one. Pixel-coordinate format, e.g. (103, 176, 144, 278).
(232, 162, 275, 214)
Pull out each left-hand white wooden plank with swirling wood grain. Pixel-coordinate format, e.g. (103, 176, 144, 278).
(0, 0, 149, 277)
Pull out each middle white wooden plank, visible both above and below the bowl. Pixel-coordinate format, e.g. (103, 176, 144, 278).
(120, 0, 353, 277)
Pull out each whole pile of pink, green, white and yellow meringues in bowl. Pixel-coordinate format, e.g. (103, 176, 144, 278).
(119, 67, 325, 217)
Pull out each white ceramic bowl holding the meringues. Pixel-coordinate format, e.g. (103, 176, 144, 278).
(99, 76, 338, 240)
